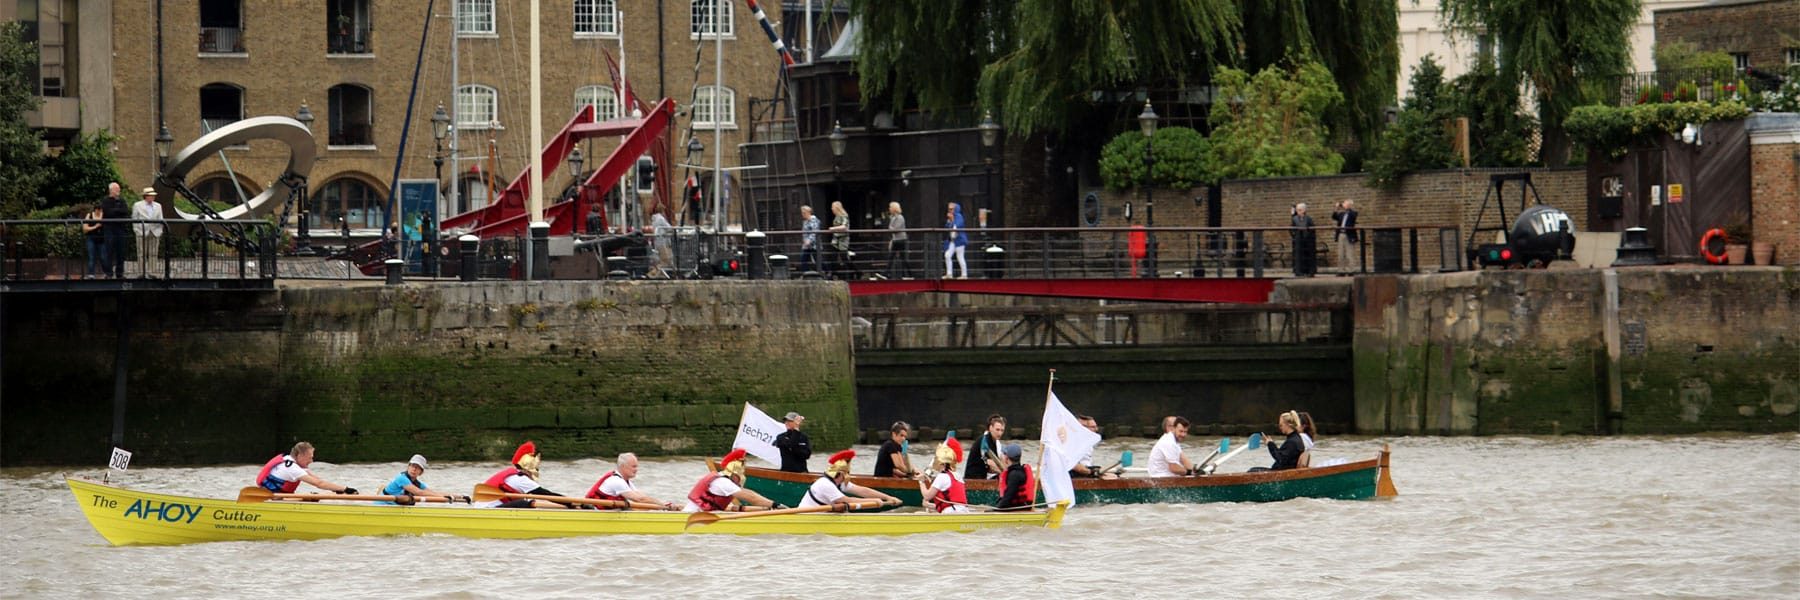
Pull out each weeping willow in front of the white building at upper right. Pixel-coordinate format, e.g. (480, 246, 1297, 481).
(1438, 0, 1640, 166)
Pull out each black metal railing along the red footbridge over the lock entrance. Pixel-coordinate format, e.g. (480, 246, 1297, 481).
(671, 225, 1463, 279)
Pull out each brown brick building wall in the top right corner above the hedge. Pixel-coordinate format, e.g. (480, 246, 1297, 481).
(1656, 0, 1800, 70)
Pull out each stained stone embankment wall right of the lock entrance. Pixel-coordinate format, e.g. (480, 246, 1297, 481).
(1352, 267, 1800, 434)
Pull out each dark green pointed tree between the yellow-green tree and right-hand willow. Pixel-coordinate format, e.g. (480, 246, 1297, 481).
(1363, 54, 1456, 187)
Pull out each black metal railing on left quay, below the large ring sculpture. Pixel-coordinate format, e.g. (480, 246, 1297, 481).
(0, 218, 281, 288)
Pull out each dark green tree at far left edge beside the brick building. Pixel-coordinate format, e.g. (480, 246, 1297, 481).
(0, 22, 43, 218)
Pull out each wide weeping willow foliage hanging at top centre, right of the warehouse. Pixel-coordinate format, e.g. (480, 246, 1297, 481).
(851, 0, 1399, 145)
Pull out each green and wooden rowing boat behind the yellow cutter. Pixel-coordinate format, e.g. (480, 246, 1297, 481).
(743, 445, 1399, 506)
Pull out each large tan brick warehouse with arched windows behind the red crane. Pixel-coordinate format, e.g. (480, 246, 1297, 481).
(10, 0, 781, 237)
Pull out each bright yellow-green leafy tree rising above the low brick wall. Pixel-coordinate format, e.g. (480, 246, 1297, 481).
(1204, 61, 1345, 180)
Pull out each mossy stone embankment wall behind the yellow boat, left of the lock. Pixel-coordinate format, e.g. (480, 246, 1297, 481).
(0, 281, 857, 465)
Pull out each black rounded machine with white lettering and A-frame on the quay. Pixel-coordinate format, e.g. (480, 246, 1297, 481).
(1467, 173, 1575, 268)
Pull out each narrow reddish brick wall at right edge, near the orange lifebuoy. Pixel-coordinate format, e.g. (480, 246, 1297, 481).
(1750, 140, 1800, 265)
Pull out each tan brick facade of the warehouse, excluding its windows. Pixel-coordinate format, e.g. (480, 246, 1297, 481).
(94, 0, 781, 224)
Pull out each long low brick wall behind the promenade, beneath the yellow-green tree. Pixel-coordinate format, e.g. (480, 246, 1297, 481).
(1102, 168, 1588, 267)
